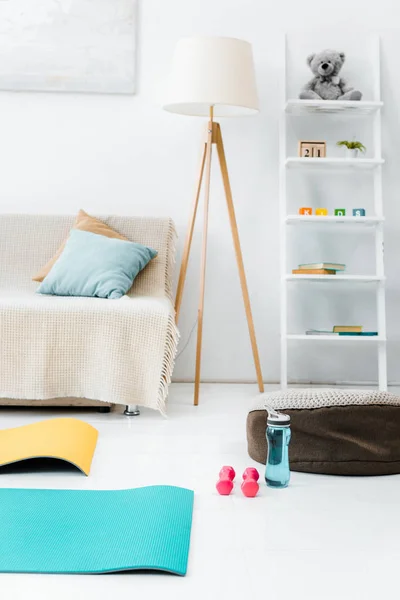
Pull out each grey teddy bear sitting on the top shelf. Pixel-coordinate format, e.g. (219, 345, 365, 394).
(299, 50, 362, 100)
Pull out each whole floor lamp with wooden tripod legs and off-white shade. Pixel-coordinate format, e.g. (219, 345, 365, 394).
(164, 37, 264, 406)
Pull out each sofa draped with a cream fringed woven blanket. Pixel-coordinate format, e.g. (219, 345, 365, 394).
(0, 215, 178, 414)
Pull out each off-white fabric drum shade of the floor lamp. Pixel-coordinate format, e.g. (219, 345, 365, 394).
(163, 37, 259, 117)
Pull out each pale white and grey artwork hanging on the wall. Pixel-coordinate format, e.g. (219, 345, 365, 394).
(0, 0, 137, 94)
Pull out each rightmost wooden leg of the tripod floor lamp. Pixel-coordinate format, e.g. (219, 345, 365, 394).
(216, 124, 264, 392)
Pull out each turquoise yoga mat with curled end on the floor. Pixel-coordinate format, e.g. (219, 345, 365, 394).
(0, 485, 193, 575)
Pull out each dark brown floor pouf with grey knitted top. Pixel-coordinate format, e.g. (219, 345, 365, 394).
(247, 389, 400, 475)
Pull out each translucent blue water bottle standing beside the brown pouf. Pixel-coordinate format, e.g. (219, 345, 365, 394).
(265, 406, 291, 488)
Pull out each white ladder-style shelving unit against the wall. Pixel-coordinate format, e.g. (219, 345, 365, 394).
(279, 36, 387, 391)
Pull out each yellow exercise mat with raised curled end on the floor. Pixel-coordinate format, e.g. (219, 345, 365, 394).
(0, 419, 99, 475)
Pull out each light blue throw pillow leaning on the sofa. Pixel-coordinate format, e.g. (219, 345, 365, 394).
(37, 229, 157, 298)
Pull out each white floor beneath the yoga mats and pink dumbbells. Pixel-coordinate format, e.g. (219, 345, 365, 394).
(0, 384, 400, 600)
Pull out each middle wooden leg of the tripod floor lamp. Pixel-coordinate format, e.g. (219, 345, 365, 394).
(194, 121, 213, 406)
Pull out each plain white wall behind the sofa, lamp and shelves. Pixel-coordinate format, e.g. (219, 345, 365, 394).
(0, 0, 400, 381)
